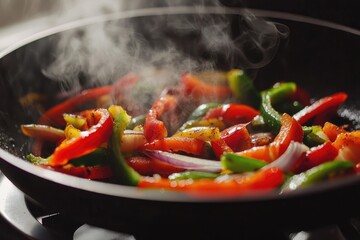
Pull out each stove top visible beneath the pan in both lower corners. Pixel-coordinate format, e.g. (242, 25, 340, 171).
(0, 172, 360, 240)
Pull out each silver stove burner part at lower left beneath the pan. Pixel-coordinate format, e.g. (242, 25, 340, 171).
(0, 173, 135, 240)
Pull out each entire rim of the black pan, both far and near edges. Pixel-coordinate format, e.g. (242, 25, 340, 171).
(0, 6, 360, 203)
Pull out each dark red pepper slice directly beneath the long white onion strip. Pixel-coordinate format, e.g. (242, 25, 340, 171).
(126, 156, 185, 177)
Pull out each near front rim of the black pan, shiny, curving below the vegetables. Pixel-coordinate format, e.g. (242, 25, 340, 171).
(0, 148, 360, 203)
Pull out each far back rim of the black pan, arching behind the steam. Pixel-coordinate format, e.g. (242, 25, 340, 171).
(0, 6, 360, 59)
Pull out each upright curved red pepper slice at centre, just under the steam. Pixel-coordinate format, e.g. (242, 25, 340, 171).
(144, 95, 177, 142)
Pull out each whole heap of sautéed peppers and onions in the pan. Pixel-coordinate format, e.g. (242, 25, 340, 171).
(21, 69, 360, 196)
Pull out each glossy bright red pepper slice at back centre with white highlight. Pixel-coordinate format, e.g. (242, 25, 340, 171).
(203, 103, 260, 126)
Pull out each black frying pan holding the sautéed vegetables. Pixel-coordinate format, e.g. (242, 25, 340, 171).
(0, 8, 360, 237)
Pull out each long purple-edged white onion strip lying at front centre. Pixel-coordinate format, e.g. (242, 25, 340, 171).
(144, 150, 222, 172)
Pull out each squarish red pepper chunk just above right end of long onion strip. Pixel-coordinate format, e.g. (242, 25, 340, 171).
(220, 123, 253, 152)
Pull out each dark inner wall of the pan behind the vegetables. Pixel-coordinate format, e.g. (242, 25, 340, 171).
(0, 8, 360, 201)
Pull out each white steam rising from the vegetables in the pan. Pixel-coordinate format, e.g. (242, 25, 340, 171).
(37, 0, 288, 115)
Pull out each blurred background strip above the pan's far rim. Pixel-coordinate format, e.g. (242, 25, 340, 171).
(0, 0, 360, 30)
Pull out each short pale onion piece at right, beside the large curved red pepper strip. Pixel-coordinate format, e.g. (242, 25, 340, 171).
(263, 142, 309, 172)
